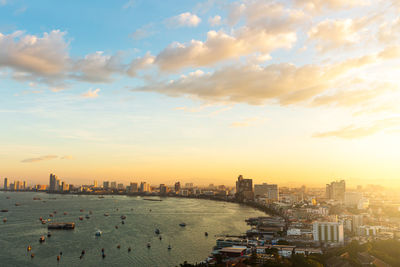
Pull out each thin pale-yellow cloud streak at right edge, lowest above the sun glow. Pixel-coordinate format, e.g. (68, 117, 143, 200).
(313, 117, 400, 139)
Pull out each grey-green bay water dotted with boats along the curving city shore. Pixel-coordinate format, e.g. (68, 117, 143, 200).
(0, 192, 265, 266)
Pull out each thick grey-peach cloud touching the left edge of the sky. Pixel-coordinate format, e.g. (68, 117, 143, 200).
(0, 30, 69, 76)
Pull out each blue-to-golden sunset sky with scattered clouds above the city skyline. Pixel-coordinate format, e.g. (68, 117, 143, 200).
(0, 0, 400, 187)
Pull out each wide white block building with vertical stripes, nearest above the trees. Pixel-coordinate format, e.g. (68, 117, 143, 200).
(313, 222, 344, 243)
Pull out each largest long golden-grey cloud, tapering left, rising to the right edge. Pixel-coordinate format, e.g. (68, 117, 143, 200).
(133, 47, 400, 105)
